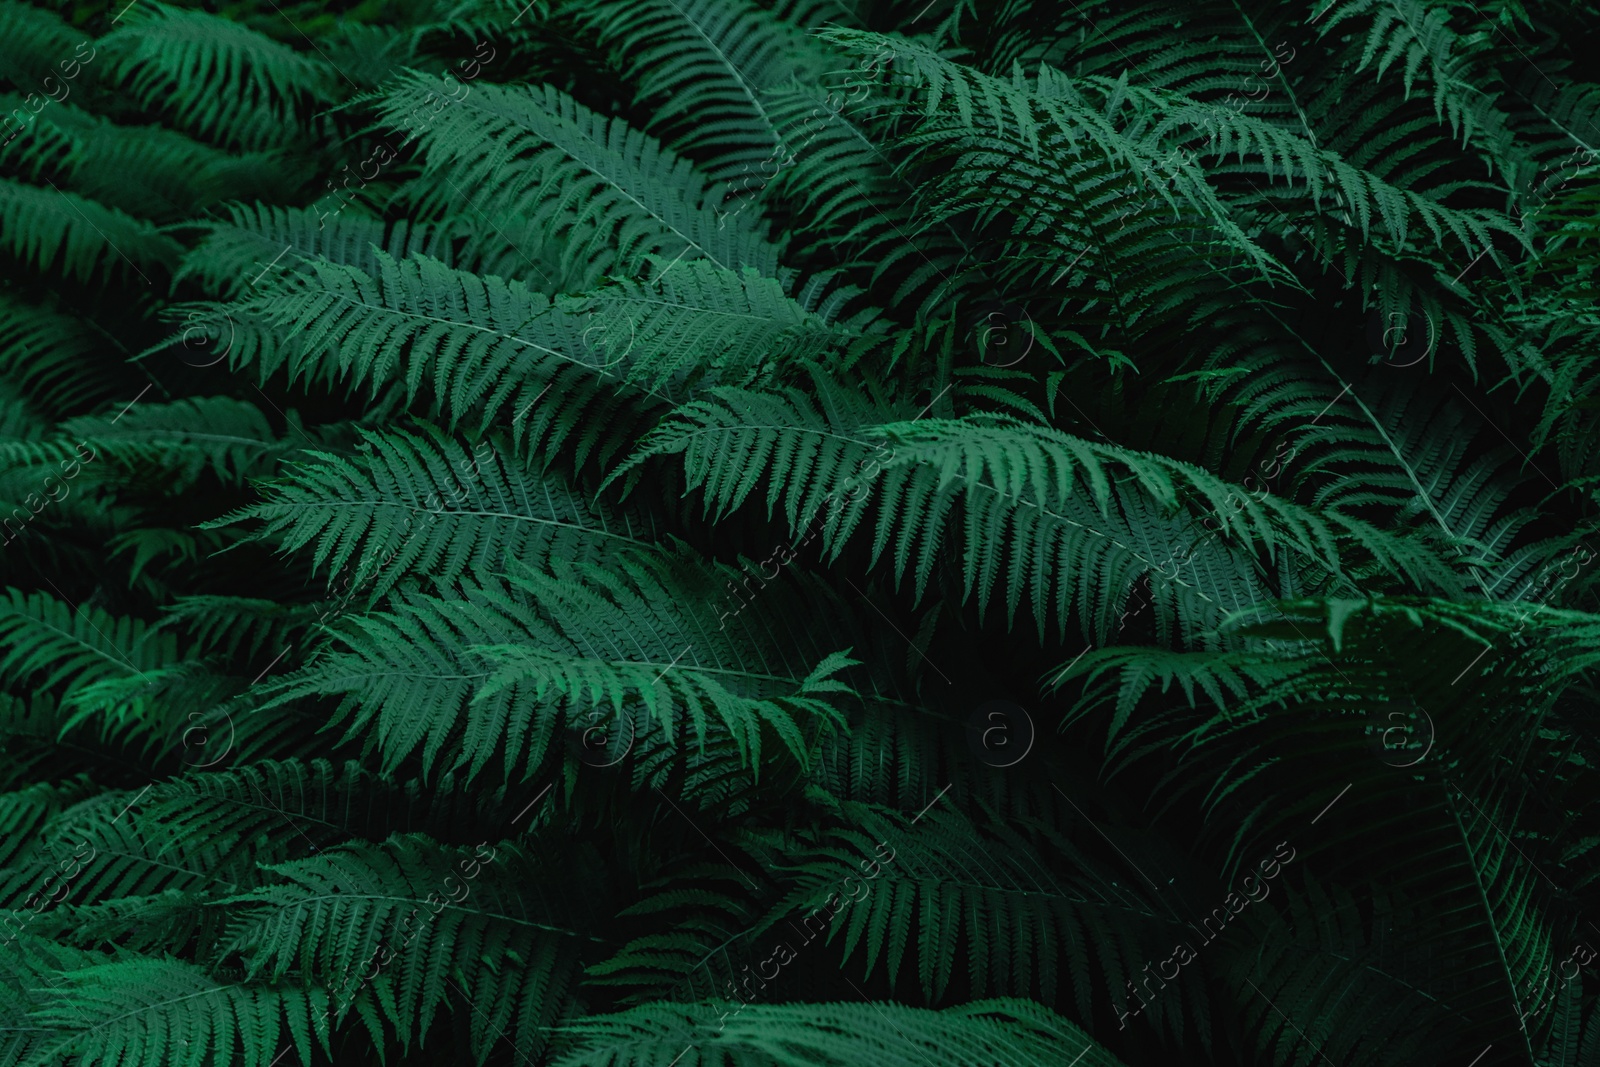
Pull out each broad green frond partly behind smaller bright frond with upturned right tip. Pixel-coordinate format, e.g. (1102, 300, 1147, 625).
(256, 543, 870, 777)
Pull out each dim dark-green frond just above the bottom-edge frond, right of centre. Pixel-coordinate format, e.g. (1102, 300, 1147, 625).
(762, 803, 1205, 1033)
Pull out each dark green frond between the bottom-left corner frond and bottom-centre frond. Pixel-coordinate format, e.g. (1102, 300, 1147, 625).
(226, 833, 602, 1062)
